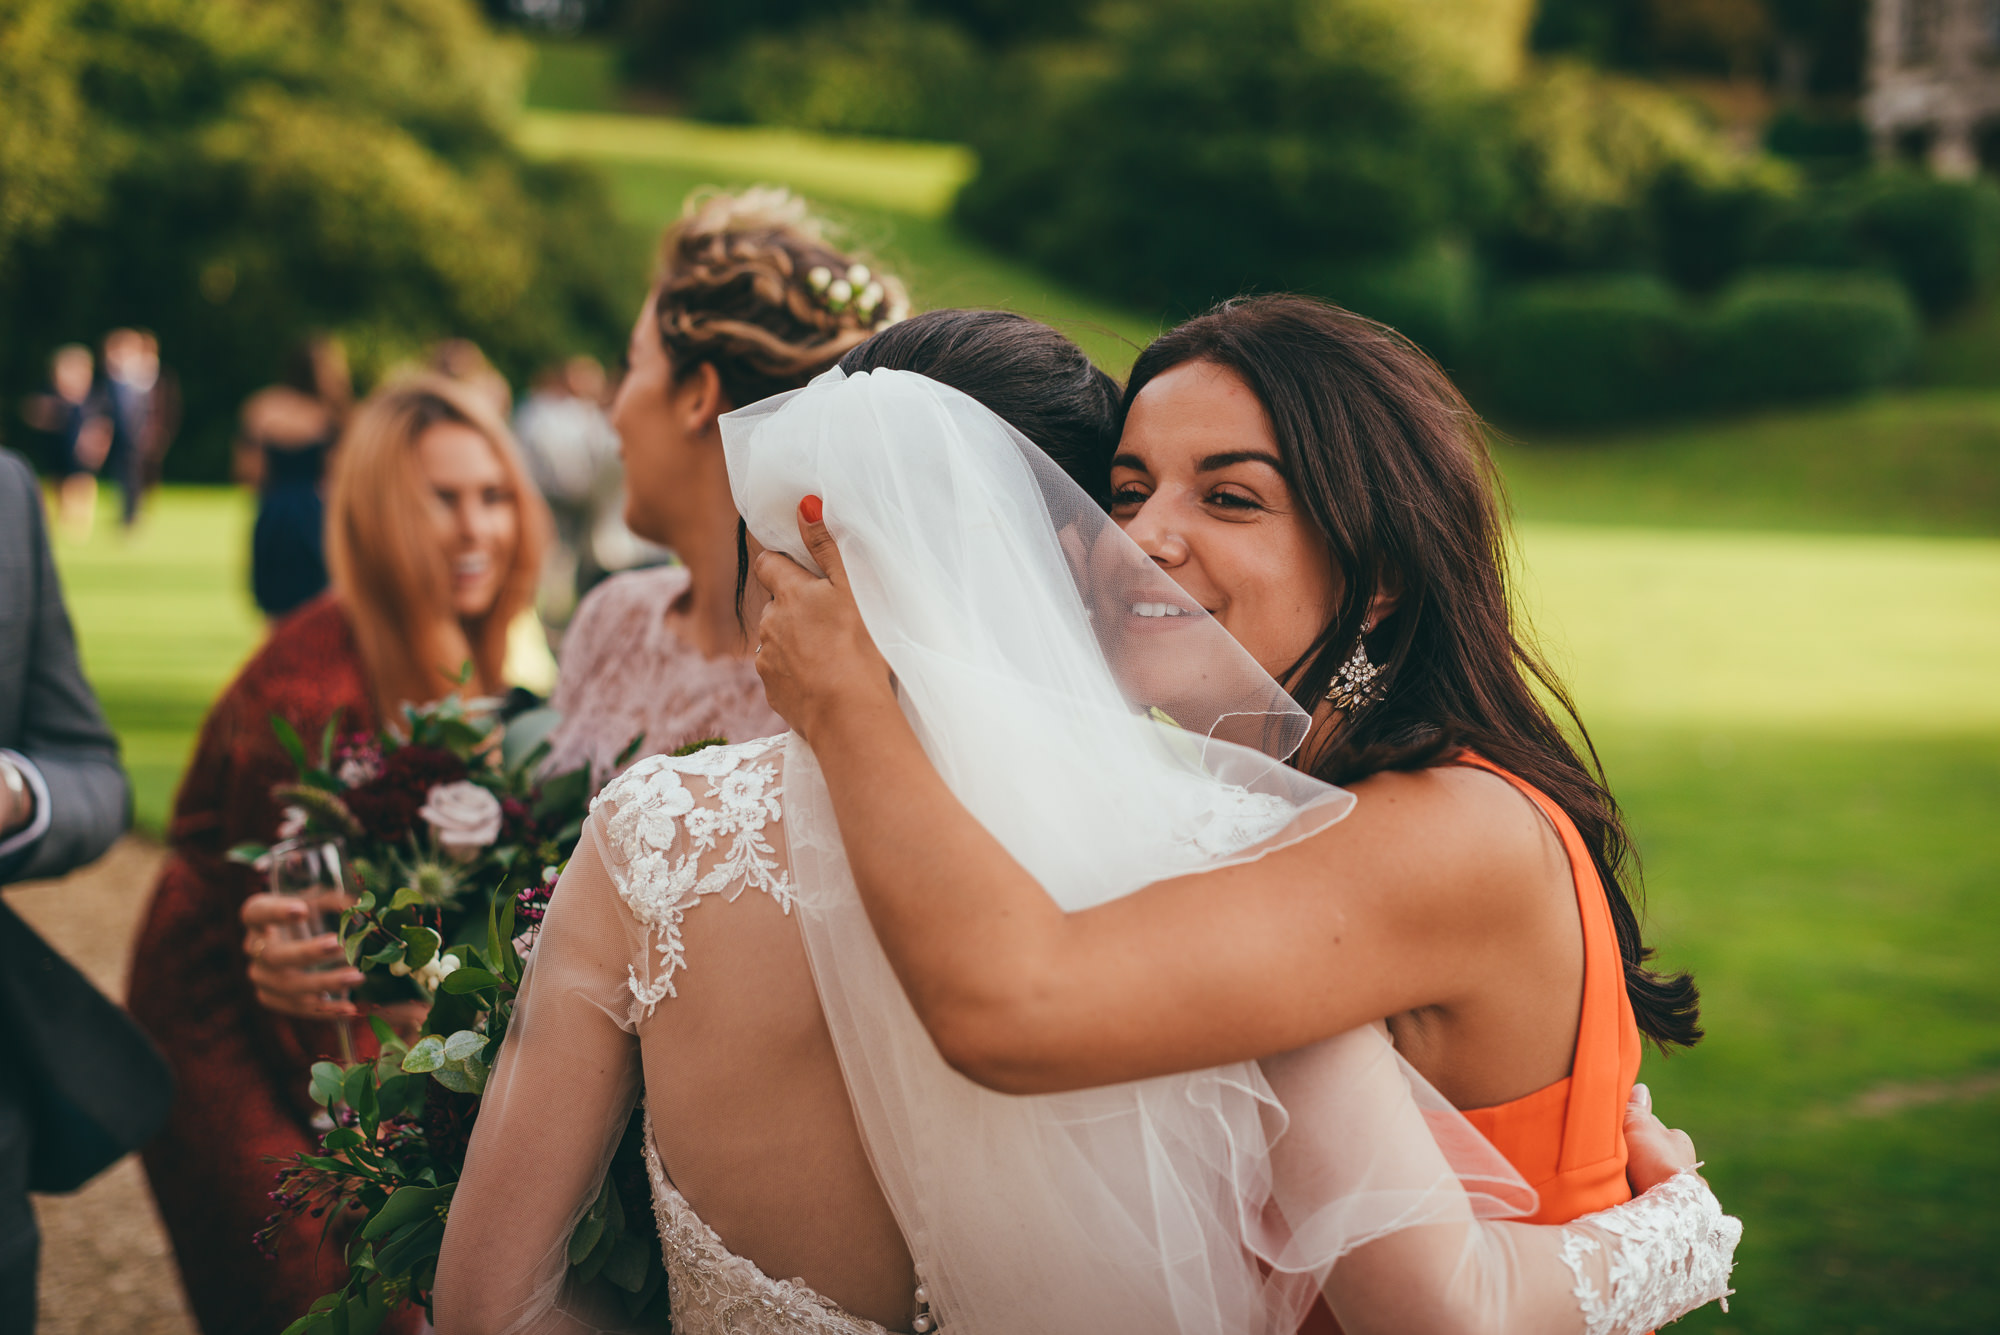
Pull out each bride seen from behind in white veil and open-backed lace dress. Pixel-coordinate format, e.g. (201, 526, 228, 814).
(434, 309, 1736, 1335)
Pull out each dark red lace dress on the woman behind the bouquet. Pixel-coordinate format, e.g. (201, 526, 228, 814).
(130, 594, 416, 1335)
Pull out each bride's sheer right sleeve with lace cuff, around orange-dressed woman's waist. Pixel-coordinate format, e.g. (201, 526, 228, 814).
(1254, 1027, 1742, 1335)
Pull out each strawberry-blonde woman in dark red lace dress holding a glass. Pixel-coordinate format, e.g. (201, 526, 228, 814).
(132, 376, 548, 1335)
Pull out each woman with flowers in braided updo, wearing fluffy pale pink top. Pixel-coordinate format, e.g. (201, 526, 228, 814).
(546, 190, 906, 783)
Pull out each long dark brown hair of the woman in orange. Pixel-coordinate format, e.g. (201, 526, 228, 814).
(1124, 296, 1702, 1047)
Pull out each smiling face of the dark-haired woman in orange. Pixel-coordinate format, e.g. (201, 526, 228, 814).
(1112, 362, 1342, 681)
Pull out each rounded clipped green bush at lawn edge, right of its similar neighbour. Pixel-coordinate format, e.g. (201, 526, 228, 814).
(1702, 272, 1922, 406)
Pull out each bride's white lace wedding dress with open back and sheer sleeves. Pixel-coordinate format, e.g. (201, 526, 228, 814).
(438, 737, 1740, 1335)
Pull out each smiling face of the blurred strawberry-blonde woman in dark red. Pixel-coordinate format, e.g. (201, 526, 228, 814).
(416, 422, 520, 620)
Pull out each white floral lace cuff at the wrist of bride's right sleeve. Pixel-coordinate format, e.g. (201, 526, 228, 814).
(1562, 1165, 1744, 1335)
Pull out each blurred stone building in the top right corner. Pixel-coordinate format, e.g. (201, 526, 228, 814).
(1862, 0, 2000, 176)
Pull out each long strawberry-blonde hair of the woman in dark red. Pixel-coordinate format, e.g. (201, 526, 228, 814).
(326, 374, 548, 721)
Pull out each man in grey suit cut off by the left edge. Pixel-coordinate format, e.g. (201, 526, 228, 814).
(0, 450, 168, 1331)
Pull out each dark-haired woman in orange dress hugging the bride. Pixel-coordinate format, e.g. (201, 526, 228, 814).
(758, 298, 1700, 1321)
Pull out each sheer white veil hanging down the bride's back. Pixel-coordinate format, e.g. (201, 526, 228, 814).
(722, 370, 1534, 1335)
